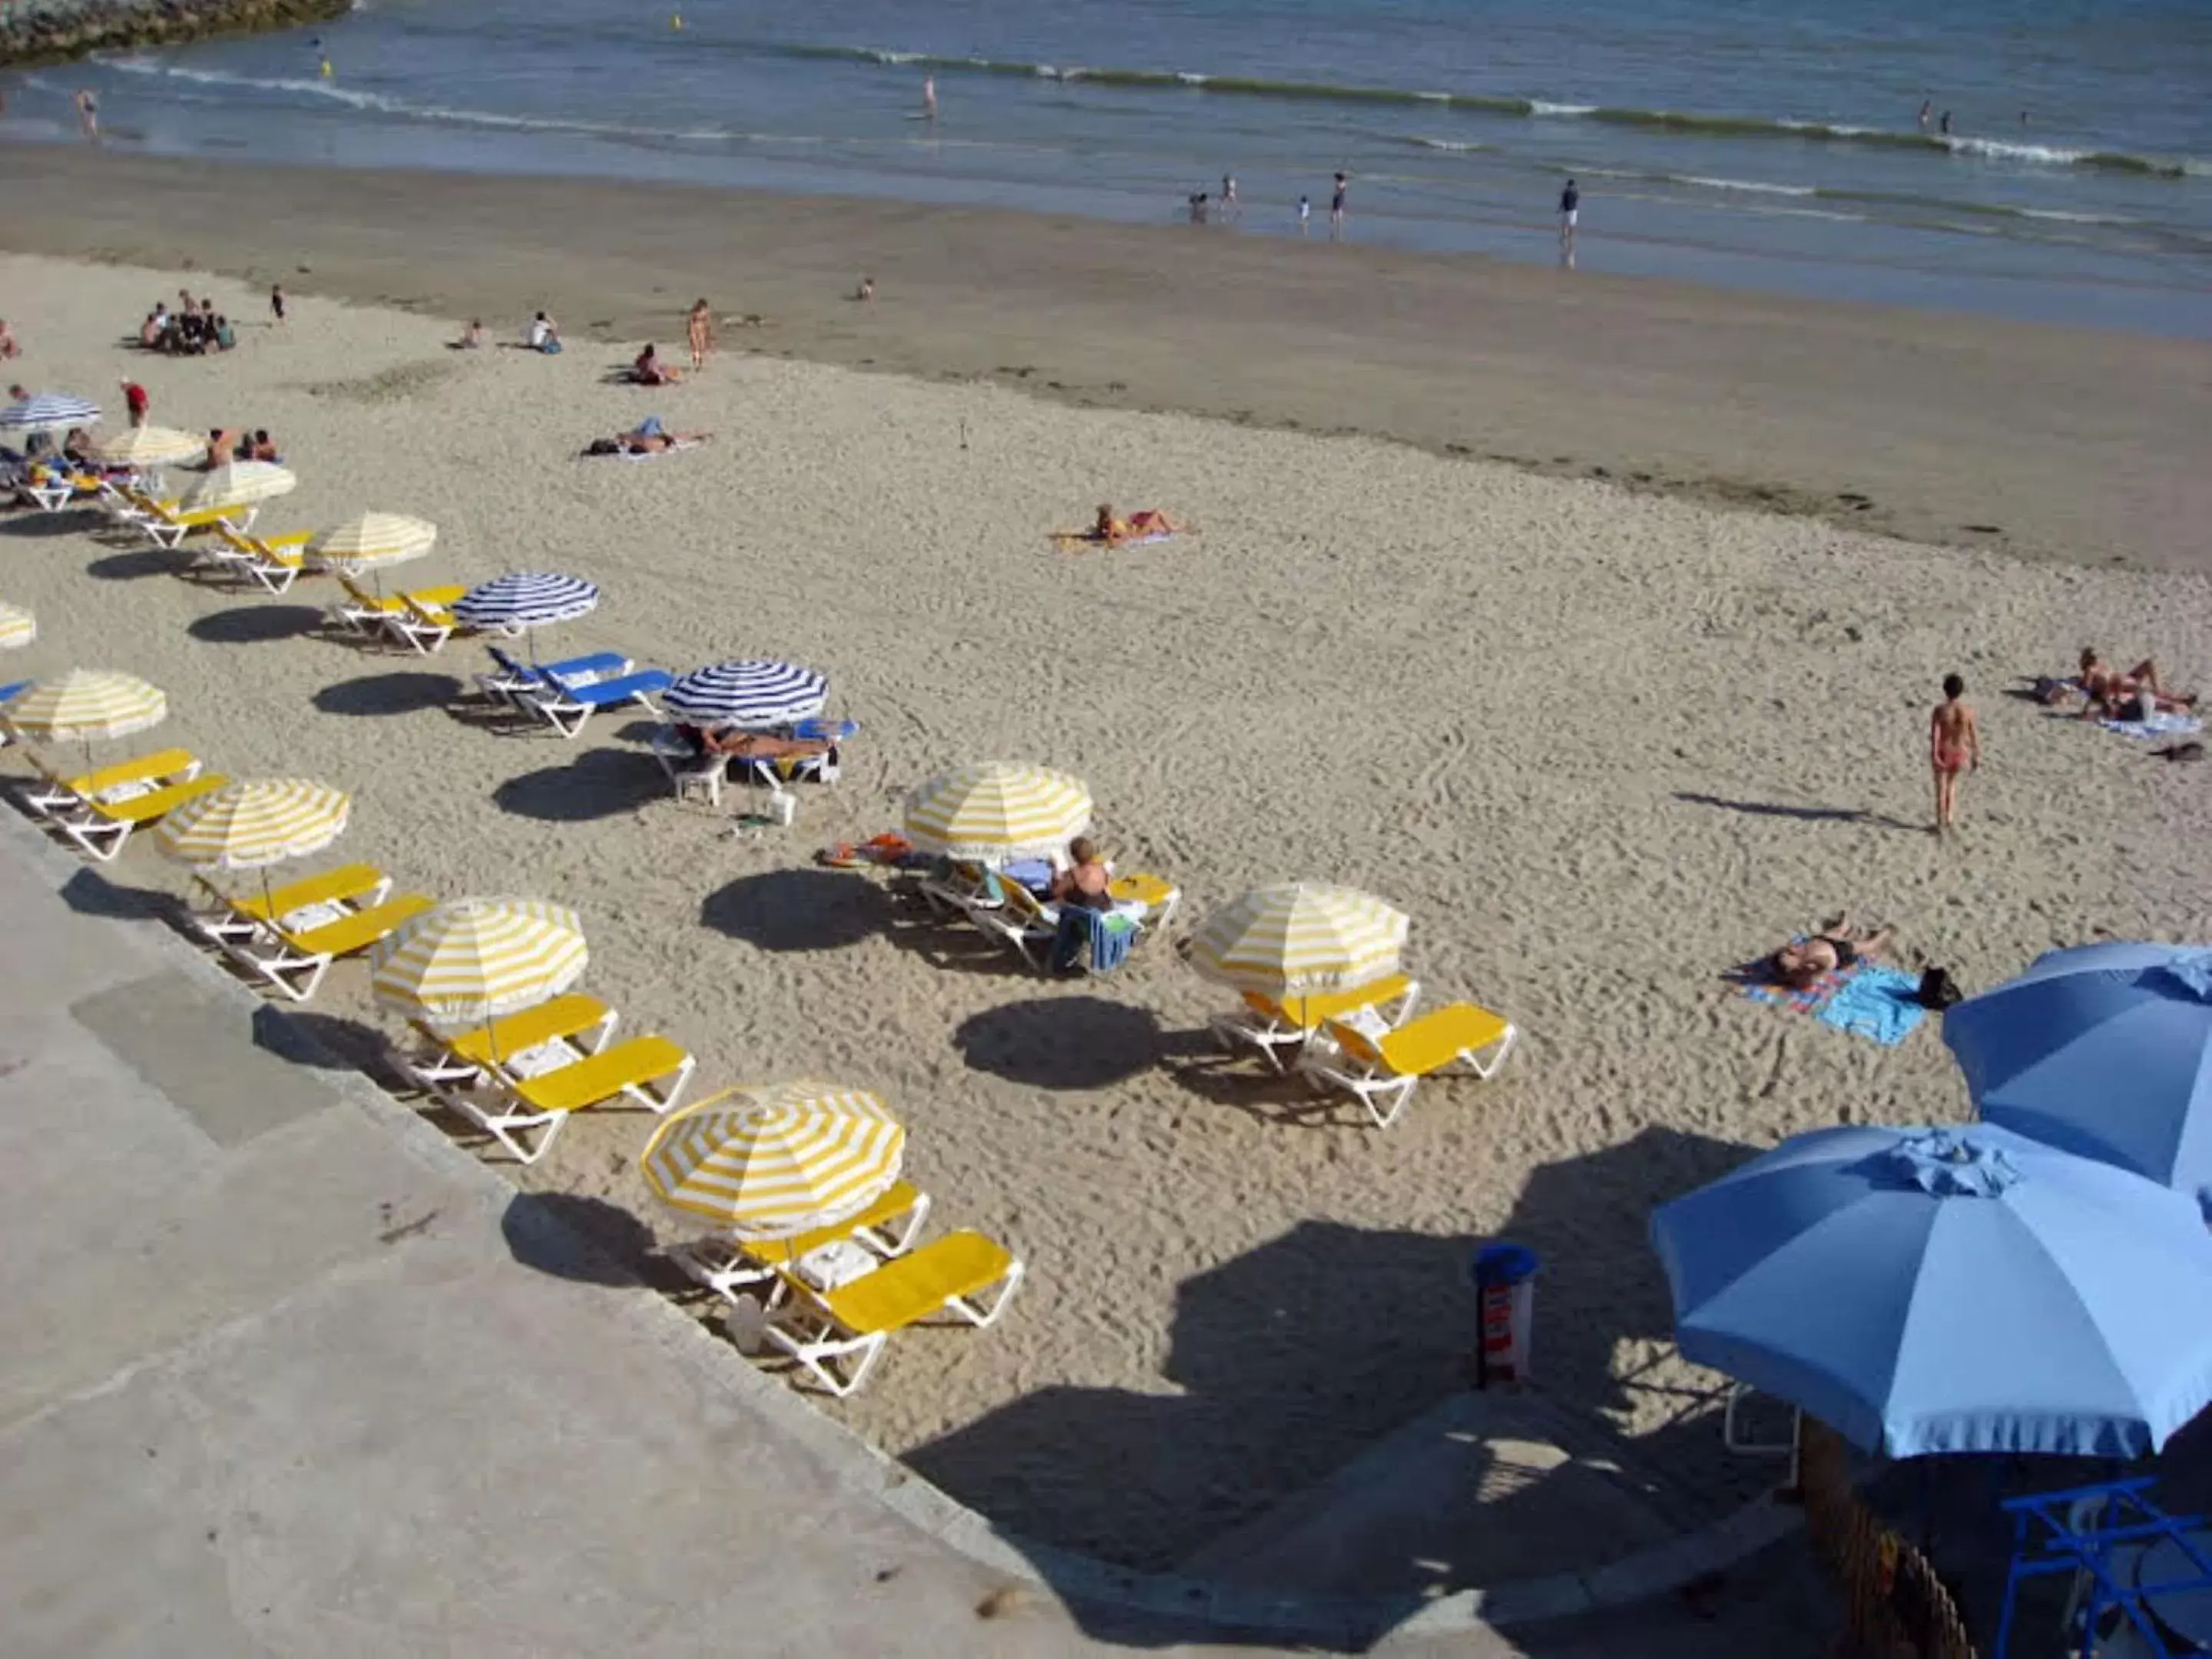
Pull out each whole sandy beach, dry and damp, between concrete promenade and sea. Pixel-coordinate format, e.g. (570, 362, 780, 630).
(0, 224, 2212, 1566)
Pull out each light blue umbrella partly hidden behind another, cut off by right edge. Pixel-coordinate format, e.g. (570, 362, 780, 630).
(1942, 945, 2212, 1204)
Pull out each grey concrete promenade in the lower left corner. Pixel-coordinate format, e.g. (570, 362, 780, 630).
(0, 827, 1805, 1659)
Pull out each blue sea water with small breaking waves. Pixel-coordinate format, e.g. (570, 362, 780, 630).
(0, 0, 2212, 336)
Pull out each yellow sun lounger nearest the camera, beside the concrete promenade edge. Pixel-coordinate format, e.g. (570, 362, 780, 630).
(761, 1232, 1024, 1400)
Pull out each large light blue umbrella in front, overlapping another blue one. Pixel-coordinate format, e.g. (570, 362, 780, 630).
(1652, 1124, 2212, 1458)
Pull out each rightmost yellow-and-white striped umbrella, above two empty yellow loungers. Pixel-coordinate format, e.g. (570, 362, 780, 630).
(1190, 880, 1407, 998)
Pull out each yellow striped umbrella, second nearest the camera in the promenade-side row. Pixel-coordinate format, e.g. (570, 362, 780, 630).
(369, 898, 591, 1026)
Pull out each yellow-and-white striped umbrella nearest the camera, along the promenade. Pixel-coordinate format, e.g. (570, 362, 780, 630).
(639, 1079, 907, 1239)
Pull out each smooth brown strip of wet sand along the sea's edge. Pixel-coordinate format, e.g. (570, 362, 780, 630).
(12, 148, 2212, 571)
